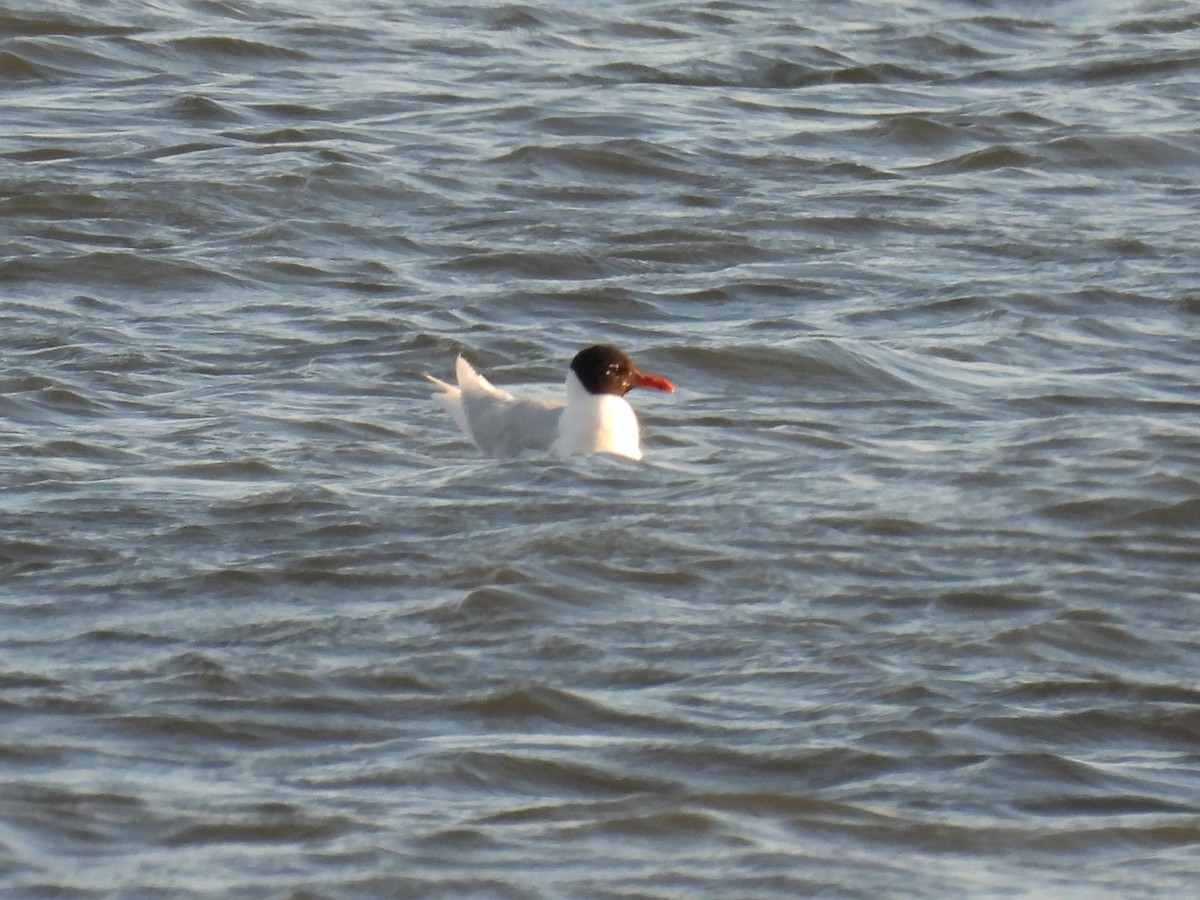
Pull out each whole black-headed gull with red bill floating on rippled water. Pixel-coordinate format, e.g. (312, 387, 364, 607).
(425, 344, 674, 460)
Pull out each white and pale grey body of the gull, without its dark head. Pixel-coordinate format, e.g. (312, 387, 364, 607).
(426, 356, 642, 460)
